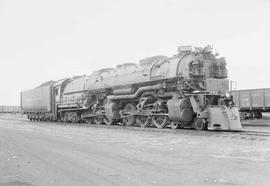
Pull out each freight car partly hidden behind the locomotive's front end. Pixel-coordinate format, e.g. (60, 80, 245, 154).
(230, 88, 270, 119)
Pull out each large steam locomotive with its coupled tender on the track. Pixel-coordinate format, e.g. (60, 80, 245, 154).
(21, 46, 241, 130)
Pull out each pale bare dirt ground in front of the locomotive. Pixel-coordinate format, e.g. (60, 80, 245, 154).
(0, 115, 270, 186)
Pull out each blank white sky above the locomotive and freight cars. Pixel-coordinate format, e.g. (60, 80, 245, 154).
(0, 0, 270, 105)
